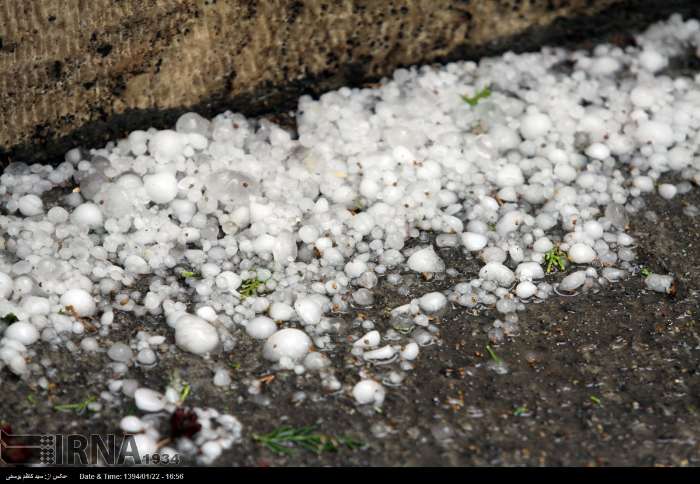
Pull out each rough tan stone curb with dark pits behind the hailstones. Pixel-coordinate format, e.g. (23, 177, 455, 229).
(0, 0, 664, 165)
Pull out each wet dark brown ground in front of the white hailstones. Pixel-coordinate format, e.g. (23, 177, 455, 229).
(1, 181, 700, 466)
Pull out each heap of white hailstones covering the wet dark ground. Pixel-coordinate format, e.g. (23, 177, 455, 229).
(0, 16, 700, 459)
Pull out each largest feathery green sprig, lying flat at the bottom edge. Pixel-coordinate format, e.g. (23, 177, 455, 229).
(253, 426, 365, 455)
